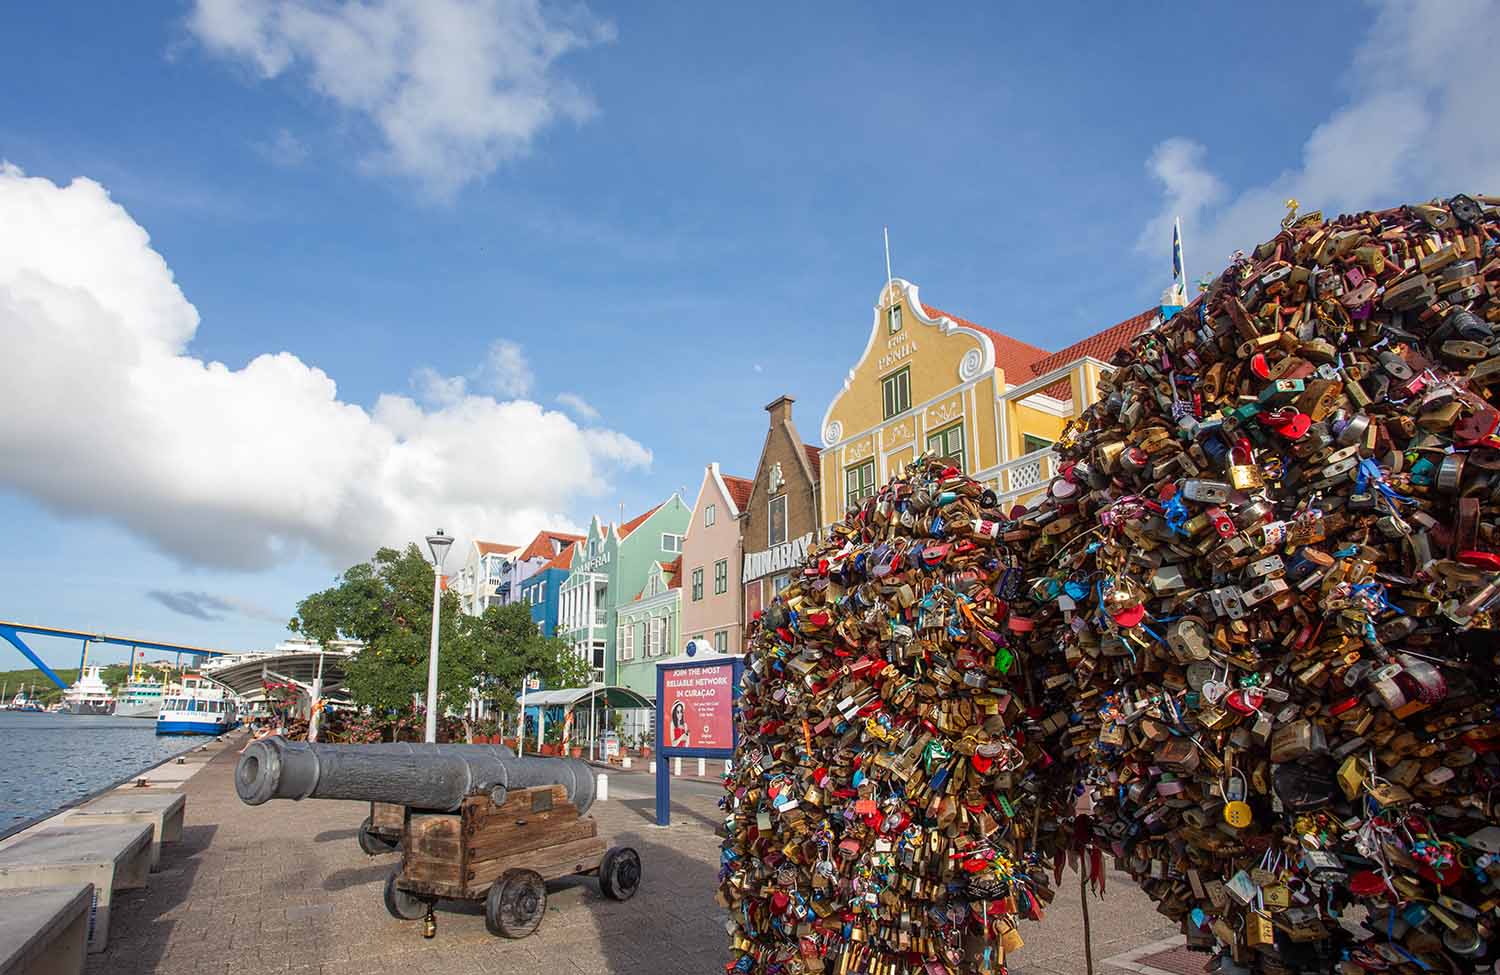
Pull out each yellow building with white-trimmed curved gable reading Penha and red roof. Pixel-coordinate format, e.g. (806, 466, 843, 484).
(821, 278, 1160, 525)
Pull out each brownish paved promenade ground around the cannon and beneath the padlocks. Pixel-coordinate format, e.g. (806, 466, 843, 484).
(87, 747, 1202, 975)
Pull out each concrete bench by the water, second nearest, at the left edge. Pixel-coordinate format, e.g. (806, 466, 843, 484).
(0, 824, 156, 951)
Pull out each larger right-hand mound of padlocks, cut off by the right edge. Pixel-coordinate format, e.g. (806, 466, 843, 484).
(1022, 197, 1500, 974)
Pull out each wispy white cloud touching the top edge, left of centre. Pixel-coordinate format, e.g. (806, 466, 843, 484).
(188, 0, 615, 197)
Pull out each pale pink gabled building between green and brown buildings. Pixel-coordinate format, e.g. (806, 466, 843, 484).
(680, 464, 753, 654)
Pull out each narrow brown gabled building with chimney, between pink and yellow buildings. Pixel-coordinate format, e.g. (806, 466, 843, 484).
(737, 396, 827, 624)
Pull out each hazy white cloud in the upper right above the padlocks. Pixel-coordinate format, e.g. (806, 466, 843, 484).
(1139, 0, 1500, 278)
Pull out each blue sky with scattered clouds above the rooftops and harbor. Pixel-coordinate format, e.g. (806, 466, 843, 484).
(0, 0, 1500, 668)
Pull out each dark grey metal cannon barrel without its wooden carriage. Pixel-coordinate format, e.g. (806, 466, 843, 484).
(234, 735, 594, 816)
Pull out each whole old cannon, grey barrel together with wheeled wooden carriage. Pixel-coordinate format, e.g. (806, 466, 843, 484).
(234, 737, 641, 938)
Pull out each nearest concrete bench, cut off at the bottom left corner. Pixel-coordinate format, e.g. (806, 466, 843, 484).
(0, 884, 93, 975)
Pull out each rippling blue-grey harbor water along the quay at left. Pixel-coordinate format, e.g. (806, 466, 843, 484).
(0, 711, 202, 837)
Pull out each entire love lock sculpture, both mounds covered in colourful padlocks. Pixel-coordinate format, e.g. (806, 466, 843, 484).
(720, 195, 1500, 975)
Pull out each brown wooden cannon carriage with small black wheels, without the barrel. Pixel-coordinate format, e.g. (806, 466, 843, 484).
(381, 786, 641, 938)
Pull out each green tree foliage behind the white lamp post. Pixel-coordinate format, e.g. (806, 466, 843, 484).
(290, 545, 588, 713)
